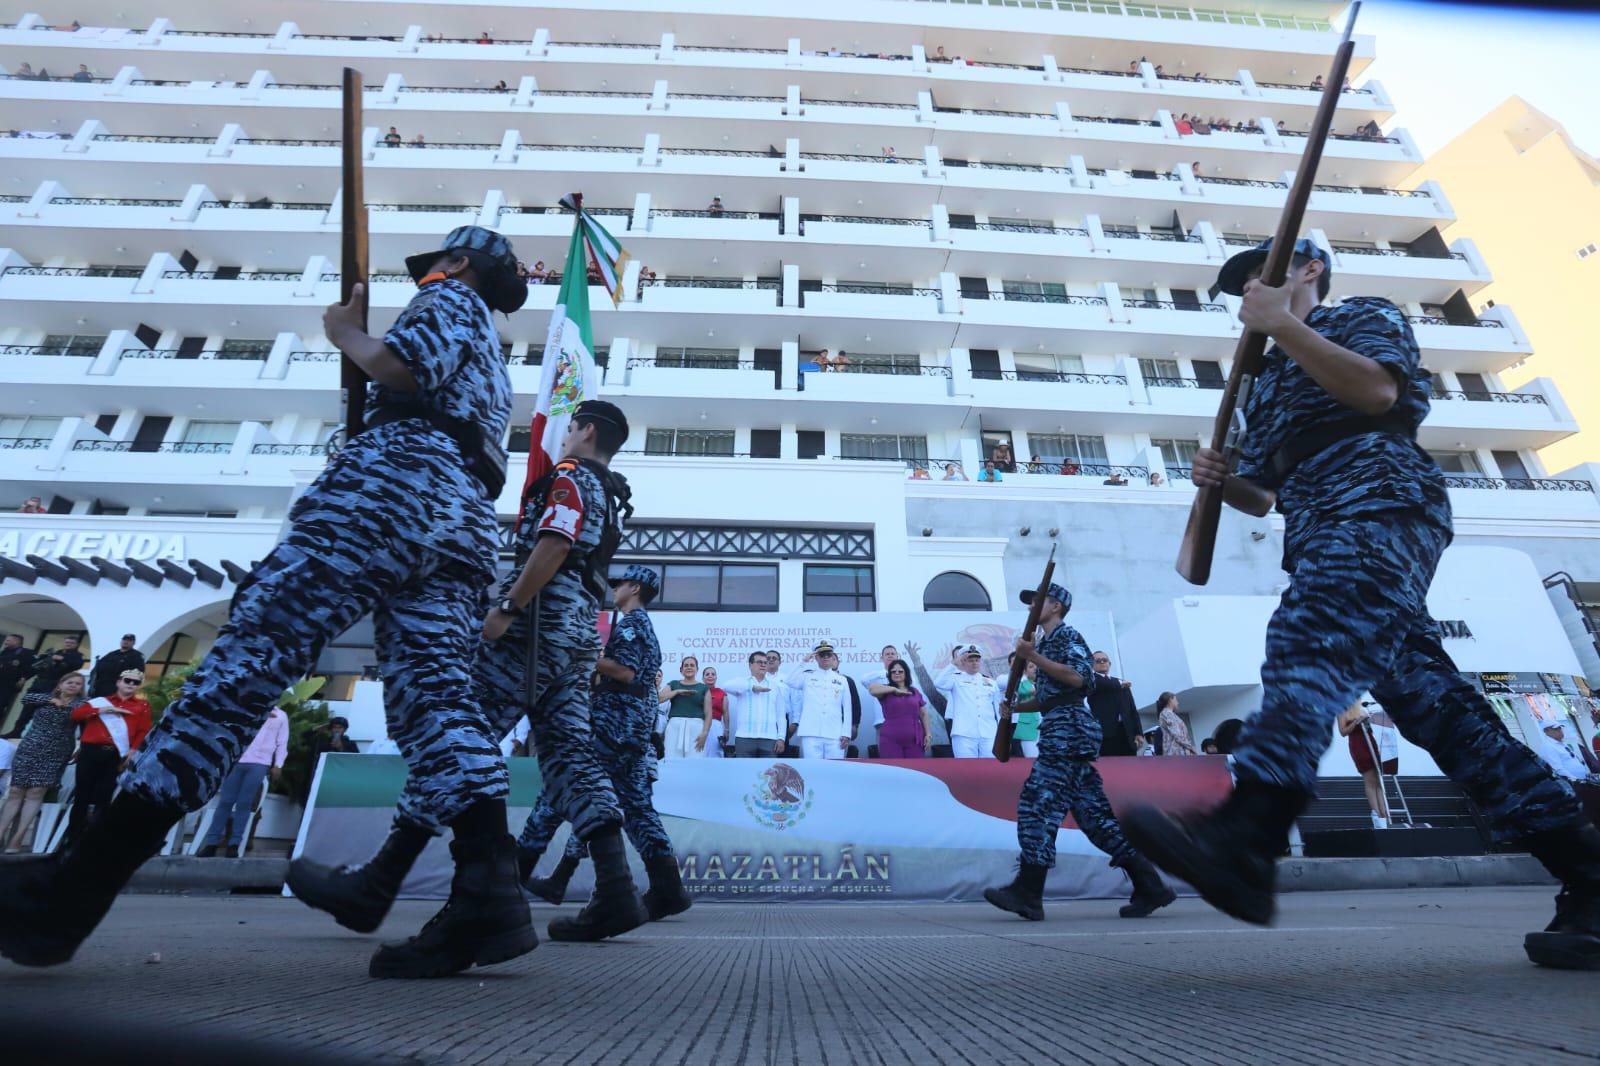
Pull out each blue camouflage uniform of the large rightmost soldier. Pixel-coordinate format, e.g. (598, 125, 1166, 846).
(1234, 298, 1579, 837)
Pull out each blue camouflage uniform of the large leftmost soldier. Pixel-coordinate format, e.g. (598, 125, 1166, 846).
(122, 279, 512, 823)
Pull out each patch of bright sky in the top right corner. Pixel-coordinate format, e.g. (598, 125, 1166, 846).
(1357, 0, 1600, 155)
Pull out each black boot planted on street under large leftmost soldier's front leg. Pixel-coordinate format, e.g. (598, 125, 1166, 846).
(366, 834, 539, 978)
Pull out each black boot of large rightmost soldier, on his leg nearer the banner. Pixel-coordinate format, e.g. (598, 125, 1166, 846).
(1120, 779, 1310, 925)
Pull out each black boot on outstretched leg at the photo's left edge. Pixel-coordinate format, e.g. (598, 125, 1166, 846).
(0, 794, 182, 967)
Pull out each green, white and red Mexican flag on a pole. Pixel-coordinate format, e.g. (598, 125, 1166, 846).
(517, 199, 627, 522)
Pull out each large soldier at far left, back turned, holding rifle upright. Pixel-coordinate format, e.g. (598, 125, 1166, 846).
(0, 226, 538, 976)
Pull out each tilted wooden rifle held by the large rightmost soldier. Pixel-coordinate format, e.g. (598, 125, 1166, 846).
(1178, 0, 1362, 584)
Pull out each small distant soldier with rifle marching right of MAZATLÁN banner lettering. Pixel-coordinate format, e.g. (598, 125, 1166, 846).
(984, 584, 1178, 922)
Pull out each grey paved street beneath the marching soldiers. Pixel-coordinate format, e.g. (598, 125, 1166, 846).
(0, 888, 1600, 1064)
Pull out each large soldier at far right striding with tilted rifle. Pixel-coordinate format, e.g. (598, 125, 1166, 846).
(1125, 240, 1600, 970)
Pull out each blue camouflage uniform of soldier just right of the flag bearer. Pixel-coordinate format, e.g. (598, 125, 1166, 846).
(517, 607, 672, 860)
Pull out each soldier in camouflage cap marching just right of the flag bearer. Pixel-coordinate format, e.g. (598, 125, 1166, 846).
(517, 565, 691, 922)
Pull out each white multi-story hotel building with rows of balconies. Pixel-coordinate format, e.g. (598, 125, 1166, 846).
(0, 0, 1600, 765)
